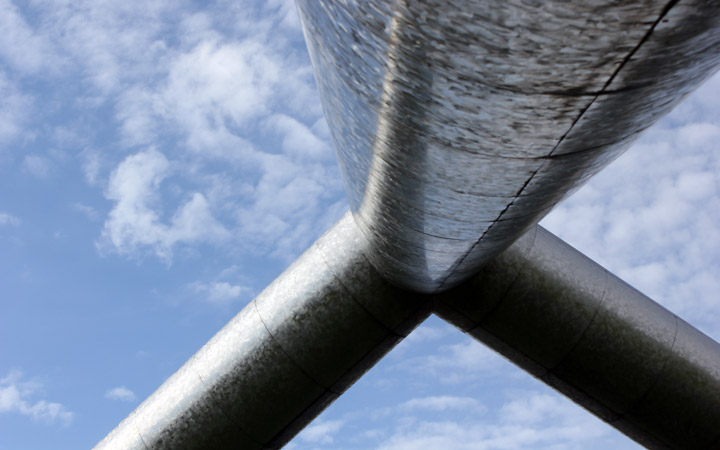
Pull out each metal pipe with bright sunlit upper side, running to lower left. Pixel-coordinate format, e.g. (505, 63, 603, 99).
(90, 214, 431, 450)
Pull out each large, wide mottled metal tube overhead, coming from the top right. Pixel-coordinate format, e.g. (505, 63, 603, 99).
(297, 0, 720, 292)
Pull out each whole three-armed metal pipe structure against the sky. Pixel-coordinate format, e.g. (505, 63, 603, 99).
(96, 0, 720, 449)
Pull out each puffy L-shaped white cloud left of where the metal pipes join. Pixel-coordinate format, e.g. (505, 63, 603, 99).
(100, 150, 229, 262)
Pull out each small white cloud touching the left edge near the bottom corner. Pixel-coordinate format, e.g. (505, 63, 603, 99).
(0, 371, 74, 426)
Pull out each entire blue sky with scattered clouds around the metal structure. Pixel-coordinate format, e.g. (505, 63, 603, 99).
(0, 0, 720, 450)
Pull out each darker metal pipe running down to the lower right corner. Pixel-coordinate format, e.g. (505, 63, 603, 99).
(436, 227, 720, 449)
